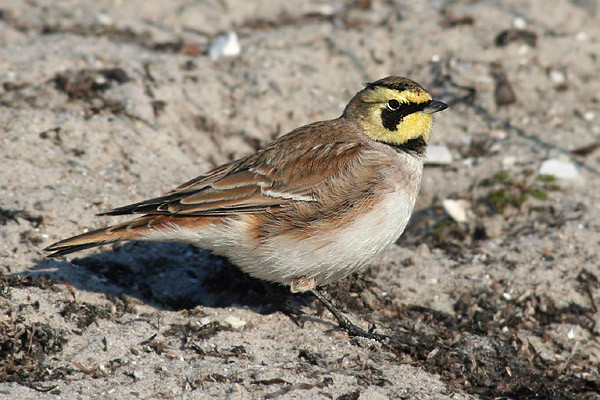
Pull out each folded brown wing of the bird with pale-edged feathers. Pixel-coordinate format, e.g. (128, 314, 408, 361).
(101, 140, 364, 216)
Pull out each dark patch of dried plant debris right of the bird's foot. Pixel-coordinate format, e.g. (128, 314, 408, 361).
(329, 271, 600, 399)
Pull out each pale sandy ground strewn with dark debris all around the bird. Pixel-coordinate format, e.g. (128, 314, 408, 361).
(0, 0, 600, 399)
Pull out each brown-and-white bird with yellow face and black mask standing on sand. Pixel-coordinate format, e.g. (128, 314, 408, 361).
(45, 76, 448, 339)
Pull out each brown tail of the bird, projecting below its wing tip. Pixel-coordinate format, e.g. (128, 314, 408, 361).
(44, 217, 156, 257)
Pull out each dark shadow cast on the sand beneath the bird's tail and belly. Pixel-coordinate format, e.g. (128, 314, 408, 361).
(29, 242, 304, 314)
